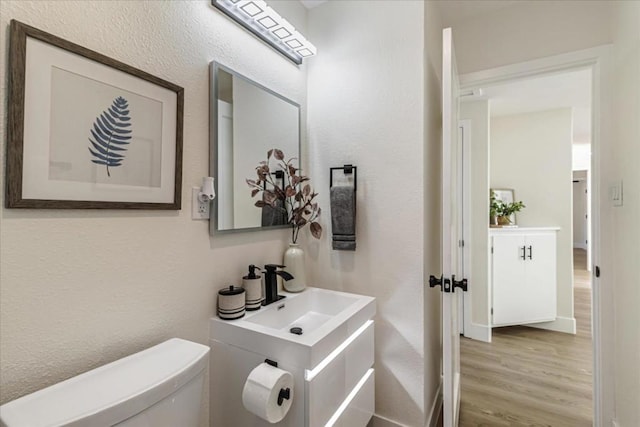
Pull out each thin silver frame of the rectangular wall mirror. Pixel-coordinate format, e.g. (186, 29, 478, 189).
(209, 61, 302, 236)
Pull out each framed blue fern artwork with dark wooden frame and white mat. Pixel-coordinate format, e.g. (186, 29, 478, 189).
(6, 20, 184, 209)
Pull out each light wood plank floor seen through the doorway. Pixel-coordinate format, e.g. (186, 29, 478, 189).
(459, 249, 592, 427)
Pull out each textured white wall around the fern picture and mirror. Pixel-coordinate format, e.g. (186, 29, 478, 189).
(0, 0, 306, 424)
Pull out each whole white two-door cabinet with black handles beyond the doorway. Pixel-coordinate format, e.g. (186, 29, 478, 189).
(489, 228, 558, 326)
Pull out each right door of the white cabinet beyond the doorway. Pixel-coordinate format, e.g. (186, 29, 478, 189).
(524, 234, 557, 323)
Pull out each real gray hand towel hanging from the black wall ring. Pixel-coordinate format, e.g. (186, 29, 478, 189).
(330, 185, 356, 251)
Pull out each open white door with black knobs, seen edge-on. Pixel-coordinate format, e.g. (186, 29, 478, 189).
(441, 28, 462, 427)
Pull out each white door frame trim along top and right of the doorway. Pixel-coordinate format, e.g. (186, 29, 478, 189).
(460, 45, 613, 427)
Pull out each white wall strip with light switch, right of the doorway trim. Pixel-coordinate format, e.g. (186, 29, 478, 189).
(603, 2, 640, 427)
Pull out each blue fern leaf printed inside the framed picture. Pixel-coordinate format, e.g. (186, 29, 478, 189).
(89, 96, 131, 177)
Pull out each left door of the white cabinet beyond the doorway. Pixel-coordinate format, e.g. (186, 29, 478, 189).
(491, 234, 526, 325)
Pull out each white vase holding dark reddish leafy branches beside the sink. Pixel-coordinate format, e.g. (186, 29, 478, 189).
(247, 148, 322, 292)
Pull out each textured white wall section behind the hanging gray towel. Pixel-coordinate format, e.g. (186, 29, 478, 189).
(307, 1, 432, 426)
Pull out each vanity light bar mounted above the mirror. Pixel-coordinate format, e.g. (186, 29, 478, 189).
(211, 0, 317, 65)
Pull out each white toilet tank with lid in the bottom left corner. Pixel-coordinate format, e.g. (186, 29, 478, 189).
(0, 338, 209, 427)
